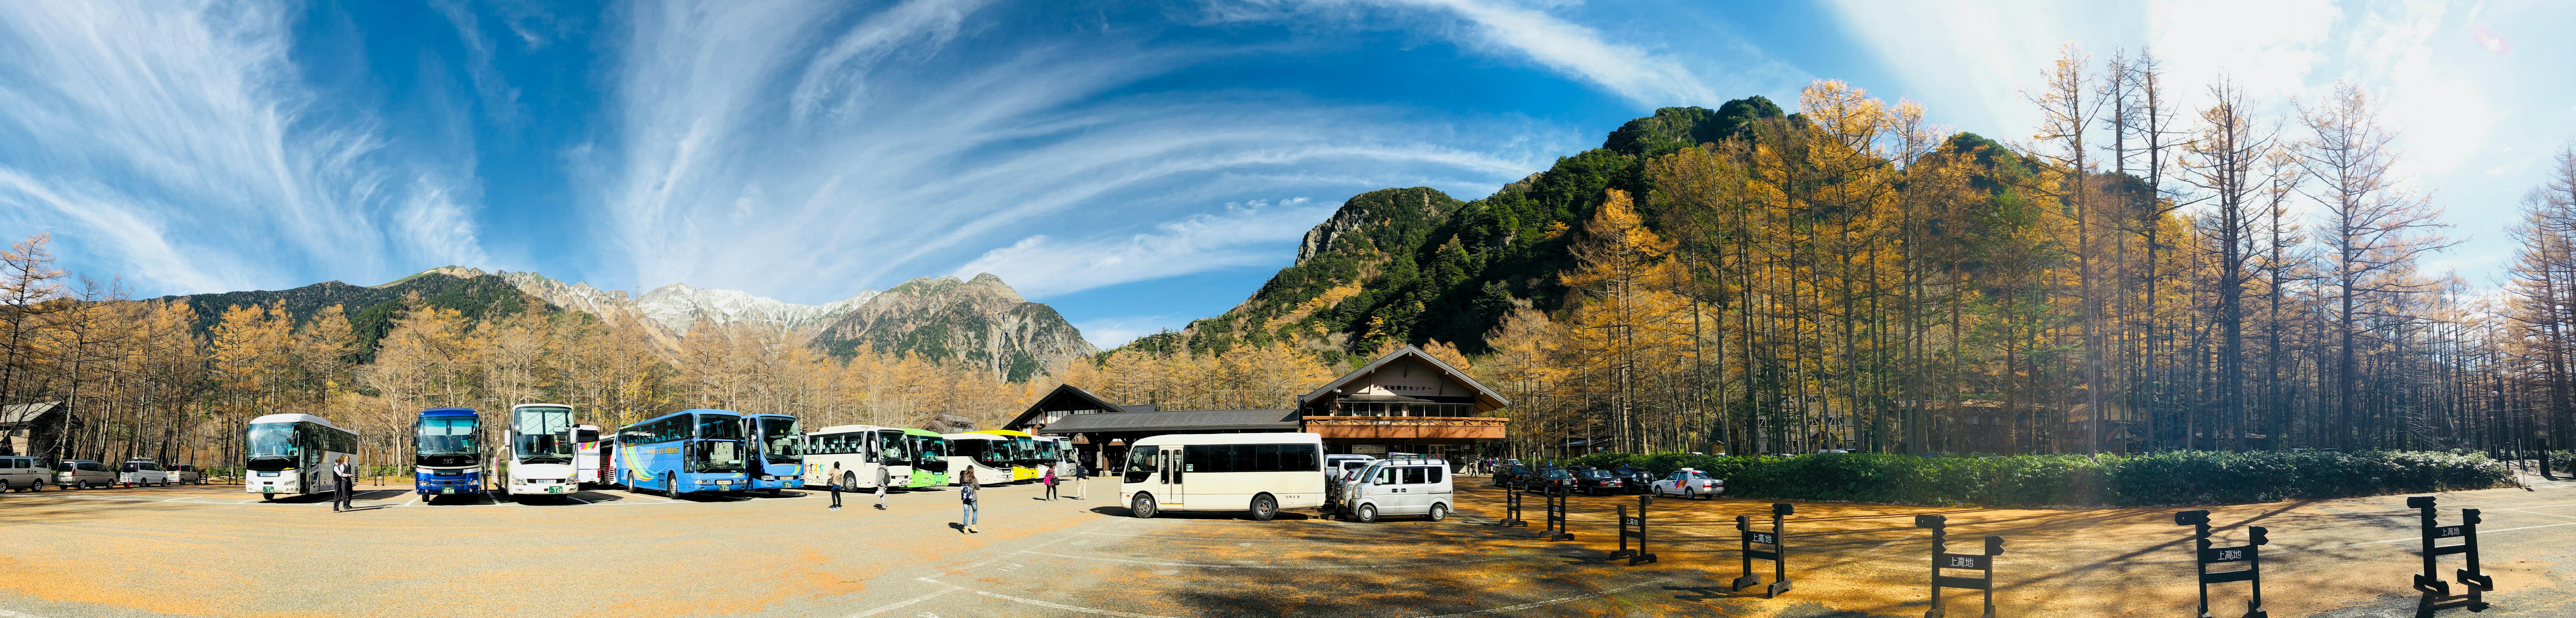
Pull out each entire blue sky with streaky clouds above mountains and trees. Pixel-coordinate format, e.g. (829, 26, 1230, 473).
(0, 0, 2576, 345)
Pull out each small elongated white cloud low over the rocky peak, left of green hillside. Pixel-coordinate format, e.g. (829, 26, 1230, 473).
(958, 198, 1334, 299)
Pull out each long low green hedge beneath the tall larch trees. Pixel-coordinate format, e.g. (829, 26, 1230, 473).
(1535, 451, 2512, 507)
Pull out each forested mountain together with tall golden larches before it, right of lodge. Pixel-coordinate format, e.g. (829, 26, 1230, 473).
(1195, 49, 2576, 456)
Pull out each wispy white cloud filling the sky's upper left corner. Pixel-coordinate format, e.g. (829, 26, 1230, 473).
(0, 3, 482, 291)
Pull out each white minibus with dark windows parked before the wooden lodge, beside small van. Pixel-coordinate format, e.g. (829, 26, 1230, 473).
(1118, 433, 1324, 520)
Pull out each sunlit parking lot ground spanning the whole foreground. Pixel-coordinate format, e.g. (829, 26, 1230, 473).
(0, 479, 2576, 618)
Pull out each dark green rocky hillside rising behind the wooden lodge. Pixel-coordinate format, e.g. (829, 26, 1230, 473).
(1174, 95, 1780, 358)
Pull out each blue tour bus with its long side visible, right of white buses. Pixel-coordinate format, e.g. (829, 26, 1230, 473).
(618, 409, 750, 497)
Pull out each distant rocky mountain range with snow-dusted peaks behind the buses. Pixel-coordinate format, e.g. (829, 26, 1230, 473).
(165, 265, 1100, 381)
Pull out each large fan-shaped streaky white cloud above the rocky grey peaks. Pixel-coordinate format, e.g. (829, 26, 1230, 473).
(582, 3, 1571, 301)
